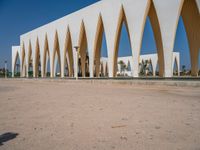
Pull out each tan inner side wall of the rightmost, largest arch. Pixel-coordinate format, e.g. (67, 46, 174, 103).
(180, 0, 200, 76)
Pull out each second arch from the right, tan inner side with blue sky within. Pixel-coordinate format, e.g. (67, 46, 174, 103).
(140, 2, 164, 76)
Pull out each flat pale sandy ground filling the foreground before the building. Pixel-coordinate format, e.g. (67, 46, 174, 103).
(0, 80, 200, 150)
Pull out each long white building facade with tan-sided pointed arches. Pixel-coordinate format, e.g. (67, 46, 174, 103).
(12, 0, 200, 77)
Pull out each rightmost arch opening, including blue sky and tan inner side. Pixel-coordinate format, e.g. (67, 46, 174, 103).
(174, 0, 200, 76)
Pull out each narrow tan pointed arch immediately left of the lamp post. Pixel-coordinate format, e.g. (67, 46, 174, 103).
(64, 27, 74, 77)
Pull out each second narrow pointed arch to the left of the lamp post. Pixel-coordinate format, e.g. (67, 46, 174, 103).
(51, 31, 61, 77)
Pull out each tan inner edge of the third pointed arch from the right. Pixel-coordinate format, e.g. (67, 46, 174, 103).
(113, 5, 132, 77)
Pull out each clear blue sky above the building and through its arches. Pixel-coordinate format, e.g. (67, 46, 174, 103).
(0, 0, 194, 69)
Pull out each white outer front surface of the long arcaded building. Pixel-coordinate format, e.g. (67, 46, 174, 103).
(12, 0, 200, 77)
